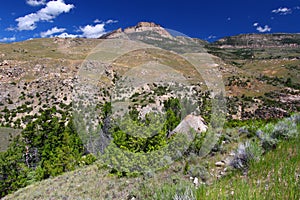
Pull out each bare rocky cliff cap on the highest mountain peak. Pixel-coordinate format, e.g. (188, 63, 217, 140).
(100, 22, 172, 39)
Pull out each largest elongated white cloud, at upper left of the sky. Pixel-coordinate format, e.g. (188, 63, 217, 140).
(16, 0, 74, 31)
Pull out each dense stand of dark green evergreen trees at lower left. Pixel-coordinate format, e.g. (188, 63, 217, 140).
(0, 107, 95, 197)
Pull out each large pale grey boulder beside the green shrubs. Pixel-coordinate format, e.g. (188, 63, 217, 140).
(168, 115, 207, 139)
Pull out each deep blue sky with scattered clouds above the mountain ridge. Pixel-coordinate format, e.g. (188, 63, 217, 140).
(0, 0, 300, 42)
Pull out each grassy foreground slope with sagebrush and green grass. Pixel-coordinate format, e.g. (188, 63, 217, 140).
(4, 115, 300, 200)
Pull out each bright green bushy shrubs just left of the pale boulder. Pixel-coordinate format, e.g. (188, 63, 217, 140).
(110, 98, 181, 153)
